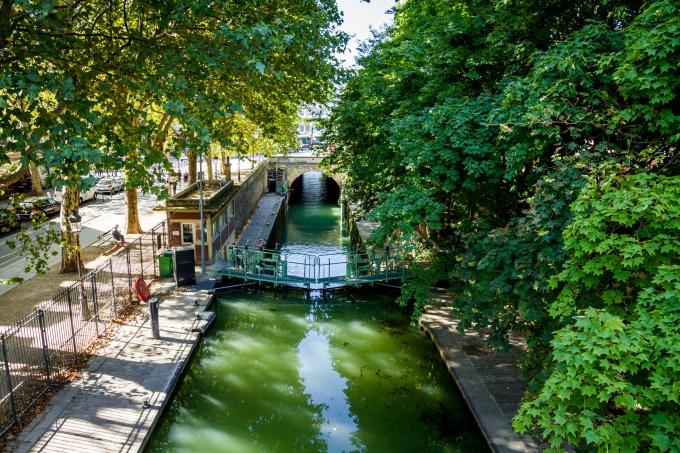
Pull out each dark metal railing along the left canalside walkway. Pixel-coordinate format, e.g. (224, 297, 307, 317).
(0, 222, 168, 436)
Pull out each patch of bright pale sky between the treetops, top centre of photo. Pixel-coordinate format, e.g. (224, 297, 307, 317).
(337, 0, 396, 66)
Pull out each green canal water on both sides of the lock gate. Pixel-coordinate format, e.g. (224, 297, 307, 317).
(146, 174, 487, 452)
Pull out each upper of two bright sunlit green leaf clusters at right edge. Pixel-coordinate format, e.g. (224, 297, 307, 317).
(550, 170, 680, 318)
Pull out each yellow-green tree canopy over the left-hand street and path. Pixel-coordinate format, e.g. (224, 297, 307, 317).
(0, 0, 347, 268)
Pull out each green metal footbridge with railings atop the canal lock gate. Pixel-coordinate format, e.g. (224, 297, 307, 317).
(217, 245, 408, 288)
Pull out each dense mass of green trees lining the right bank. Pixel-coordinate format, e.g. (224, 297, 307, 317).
(324, 0, 680, 450)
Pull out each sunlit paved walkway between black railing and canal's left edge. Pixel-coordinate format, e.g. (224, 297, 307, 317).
(10, 284, 210, 453)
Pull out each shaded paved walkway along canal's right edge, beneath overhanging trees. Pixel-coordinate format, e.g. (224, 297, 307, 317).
(418, 295, 540, 453)
